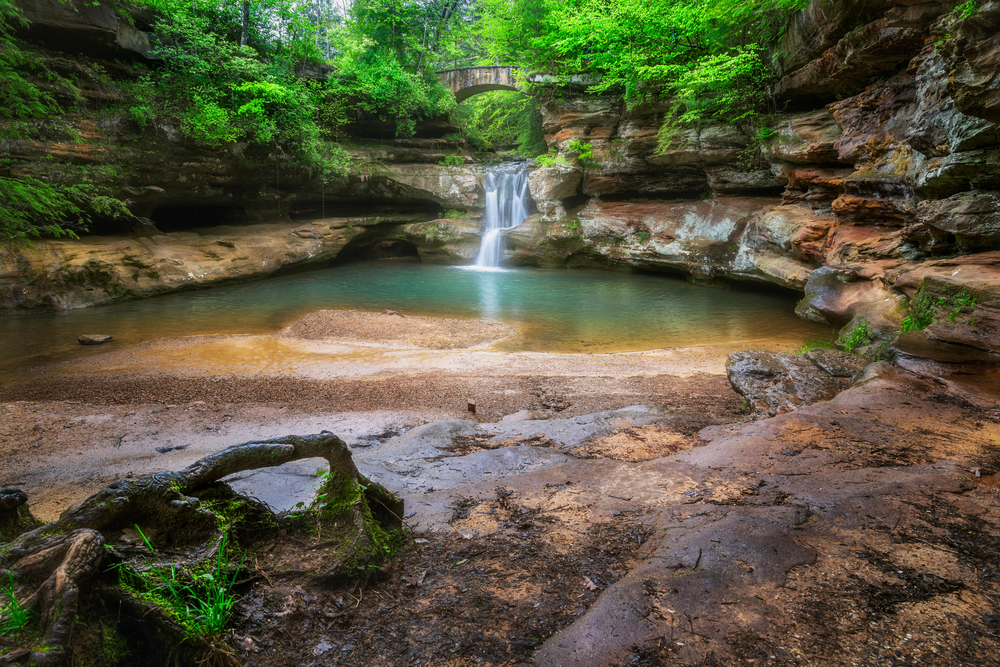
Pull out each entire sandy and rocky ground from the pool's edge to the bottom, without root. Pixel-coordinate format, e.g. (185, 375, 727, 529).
(0, 315, 1000, 666)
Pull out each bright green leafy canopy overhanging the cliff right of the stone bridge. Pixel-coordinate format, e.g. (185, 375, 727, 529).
(477, 0, 808, 136)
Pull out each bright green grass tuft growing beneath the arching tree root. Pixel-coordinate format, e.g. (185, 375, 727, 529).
(114, 526, 242, 637)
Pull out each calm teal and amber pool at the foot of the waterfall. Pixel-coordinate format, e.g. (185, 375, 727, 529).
(0, 262, 830, 370)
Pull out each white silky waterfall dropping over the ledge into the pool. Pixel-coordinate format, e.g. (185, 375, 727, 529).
(470, 163, 528, 270)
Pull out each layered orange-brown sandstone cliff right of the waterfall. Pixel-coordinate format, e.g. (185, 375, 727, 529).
(510, 0, 1000, 342)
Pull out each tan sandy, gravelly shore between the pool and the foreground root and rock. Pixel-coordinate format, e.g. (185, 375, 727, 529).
(0, 311, 744, 519)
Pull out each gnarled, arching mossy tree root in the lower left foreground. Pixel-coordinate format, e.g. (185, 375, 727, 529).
(0, 431, 403, 667)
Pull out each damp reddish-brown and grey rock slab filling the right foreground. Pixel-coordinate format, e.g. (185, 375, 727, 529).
(230, 366, 1000, 665)
